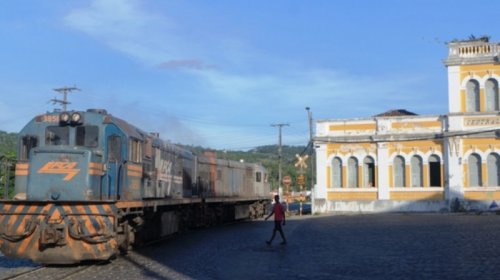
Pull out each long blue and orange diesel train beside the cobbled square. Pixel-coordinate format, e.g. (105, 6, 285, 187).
(0, 109, 270, 264)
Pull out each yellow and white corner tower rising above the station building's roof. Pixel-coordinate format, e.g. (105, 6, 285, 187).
(444, 37, 500, 114)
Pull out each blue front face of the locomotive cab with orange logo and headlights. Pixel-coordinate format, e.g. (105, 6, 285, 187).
(15, 112, 104, 201)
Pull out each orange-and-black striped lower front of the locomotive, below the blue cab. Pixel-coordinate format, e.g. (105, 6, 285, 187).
(0, 202, 118, 264)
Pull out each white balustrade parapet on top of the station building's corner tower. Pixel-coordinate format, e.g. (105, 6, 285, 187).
(443, 37, 500, 66)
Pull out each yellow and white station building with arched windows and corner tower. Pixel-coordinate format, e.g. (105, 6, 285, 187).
(313, 38, 500, 212)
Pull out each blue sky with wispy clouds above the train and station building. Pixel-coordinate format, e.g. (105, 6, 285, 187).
(0, 0, 500, 150)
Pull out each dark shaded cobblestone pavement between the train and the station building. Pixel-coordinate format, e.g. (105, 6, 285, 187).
(0, 214, 500, 279)
